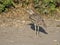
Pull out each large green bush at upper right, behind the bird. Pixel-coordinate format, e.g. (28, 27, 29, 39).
(34, 0, 60, 14)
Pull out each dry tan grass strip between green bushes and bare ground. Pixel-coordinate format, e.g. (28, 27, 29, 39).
(0, 4, 60, 20)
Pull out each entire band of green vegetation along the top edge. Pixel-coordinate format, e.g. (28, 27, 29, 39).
(0, 0, 60, 14)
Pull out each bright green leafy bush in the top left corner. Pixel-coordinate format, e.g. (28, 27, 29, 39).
(0, 0, 14, 13)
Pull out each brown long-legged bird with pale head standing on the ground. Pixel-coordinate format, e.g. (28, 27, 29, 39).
(25, 8, 46, 35)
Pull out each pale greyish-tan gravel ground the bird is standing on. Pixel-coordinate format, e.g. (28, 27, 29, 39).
(0, 20, 60, 45)
